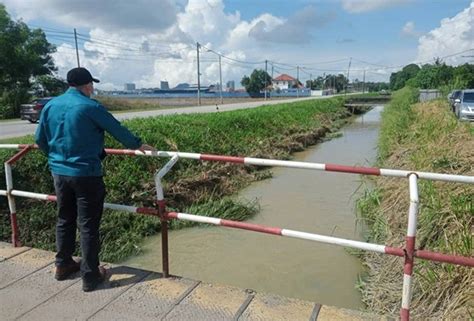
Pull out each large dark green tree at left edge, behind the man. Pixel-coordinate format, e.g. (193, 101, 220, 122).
(0, 4, 56, 118)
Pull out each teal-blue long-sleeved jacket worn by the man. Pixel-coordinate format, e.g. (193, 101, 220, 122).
(36, 88, 141, 176)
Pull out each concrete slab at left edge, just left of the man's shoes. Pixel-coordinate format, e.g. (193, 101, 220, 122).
(0, 249, 55, 289)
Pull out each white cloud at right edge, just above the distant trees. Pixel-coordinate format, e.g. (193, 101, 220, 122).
(417, 2, 474, 65)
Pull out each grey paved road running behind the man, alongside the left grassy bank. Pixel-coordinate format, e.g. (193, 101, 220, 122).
(0, 96, 334, 139)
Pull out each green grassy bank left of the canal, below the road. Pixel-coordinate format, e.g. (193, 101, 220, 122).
(0, 98, 350, 261)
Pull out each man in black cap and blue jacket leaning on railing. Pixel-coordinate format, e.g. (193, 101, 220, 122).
(36, 68, 154, 292)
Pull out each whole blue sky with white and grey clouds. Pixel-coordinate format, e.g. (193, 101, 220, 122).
(0, 0, 474, 90)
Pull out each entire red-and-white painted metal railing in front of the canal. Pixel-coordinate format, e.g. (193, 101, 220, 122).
(0, 144, 474, 320)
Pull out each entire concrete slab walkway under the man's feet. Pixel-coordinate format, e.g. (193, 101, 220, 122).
(0, 242, 385, 321)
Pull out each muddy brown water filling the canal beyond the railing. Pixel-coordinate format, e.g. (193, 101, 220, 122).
(122, 106, 383, 308)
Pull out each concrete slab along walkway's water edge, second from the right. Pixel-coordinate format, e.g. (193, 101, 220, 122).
(239, 293, 319, 321)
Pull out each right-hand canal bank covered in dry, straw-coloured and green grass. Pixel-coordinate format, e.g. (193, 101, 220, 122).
(358, 89, 474, 320)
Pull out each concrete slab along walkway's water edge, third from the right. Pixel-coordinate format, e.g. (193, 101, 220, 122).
(163, 284, 248, 321)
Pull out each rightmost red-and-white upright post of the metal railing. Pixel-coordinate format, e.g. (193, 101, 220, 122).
(400, 173, 419, 321)
